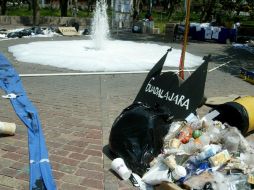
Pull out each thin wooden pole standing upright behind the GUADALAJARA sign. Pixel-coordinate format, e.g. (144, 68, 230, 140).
(179, 0, 191, 79)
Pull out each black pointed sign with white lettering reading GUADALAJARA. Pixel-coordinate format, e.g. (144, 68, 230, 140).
(134, 49, 210, 119)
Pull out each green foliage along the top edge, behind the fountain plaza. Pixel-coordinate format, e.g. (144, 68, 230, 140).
(2, 0, 254, 32)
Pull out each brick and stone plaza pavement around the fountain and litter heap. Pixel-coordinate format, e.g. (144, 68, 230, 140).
(0, 31, 254, 190)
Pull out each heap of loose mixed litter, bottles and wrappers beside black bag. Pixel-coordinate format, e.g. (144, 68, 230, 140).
(140, 114, 254, 190)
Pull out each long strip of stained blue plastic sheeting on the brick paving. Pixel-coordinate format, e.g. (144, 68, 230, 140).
(0, 53, 56, 190)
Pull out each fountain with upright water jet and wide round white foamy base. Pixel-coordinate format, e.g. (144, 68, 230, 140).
(9, 0, 203, 72)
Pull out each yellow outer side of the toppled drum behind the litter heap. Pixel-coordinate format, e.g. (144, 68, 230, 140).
(234, 96, 254, 133)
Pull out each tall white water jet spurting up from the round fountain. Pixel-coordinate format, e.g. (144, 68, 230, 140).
(92, 0, 109, 49)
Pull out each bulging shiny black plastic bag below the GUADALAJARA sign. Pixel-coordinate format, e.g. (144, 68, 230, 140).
(109, 103, 171, 176)
